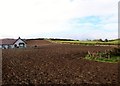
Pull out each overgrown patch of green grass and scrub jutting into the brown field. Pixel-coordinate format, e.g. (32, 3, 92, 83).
(85, 48, 120, 62)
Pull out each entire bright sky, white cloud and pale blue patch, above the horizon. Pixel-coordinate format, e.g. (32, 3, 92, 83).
(0, 0, 119, 40)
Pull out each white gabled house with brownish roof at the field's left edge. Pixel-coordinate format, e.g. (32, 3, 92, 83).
(0, 37, 26, 49)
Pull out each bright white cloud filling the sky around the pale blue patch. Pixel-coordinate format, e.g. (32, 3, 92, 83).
(0, 0, 118, 37)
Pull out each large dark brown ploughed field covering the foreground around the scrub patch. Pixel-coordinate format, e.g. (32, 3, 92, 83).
(2, 40, 118, 86)
